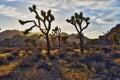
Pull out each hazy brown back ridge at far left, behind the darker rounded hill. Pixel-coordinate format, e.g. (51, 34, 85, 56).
(0, 30, 23, 41)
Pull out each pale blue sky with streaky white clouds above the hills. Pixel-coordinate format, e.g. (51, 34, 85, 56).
(0, 0, 120, 39)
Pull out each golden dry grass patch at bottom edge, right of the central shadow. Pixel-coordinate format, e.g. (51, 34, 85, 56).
(61, 61, 93, 80)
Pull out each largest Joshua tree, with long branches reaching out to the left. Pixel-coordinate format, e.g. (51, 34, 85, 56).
(19, 5, 55, 58)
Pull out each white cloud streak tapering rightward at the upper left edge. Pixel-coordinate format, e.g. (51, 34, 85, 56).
(0, 4, 27, 18)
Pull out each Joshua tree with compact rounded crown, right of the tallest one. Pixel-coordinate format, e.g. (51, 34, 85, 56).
(66, 12, 90, 55)
